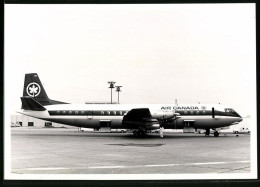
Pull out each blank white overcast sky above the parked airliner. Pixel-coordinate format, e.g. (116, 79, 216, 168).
(5, 4, 256, 115)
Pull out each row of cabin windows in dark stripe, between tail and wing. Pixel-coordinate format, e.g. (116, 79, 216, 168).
(57, 110, 126, 115)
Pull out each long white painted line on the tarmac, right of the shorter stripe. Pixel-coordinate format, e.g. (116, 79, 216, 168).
(88, 160, 250, 169)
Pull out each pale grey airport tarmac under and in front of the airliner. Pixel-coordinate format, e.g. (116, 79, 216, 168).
(11, 127, 250, 174)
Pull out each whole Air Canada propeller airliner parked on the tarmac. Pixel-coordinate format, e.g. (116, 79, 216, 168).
(19, 73, 242, 137)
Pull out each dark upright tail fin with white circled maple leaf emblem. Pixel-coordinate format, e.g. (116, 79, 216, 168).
(23, 73, 67, 106)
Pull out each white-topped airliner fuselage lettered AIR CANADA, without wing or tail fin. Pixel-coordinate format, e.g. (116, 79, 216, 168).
(21, 104, 242, 129)
